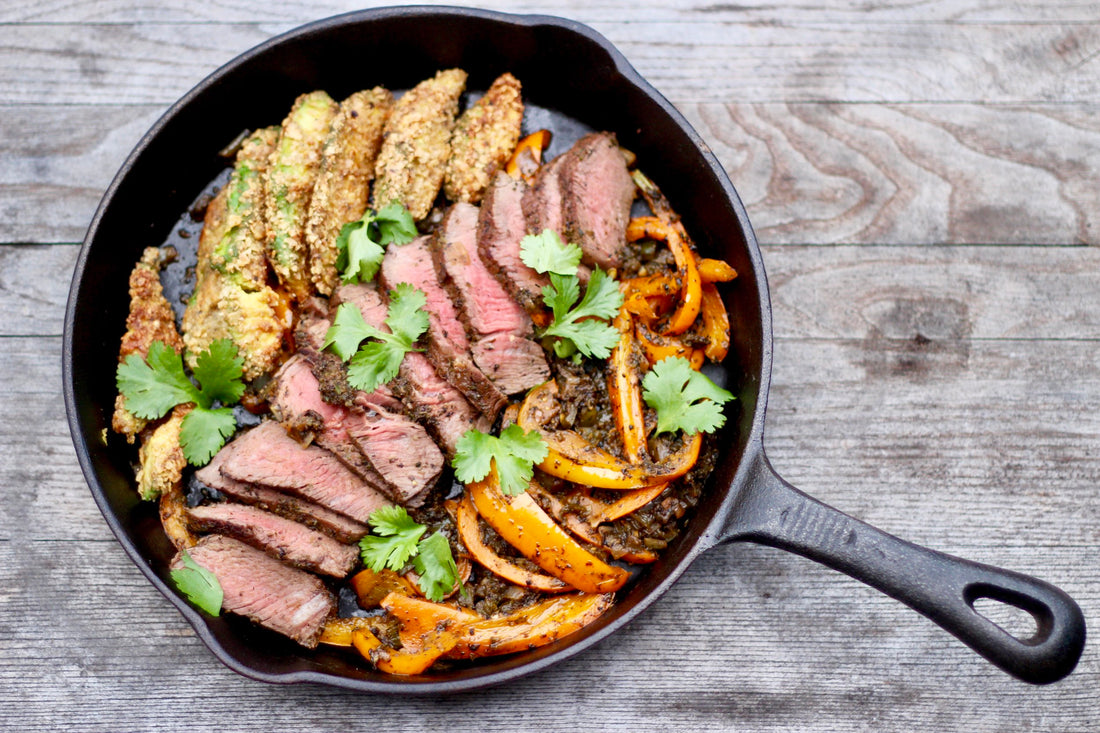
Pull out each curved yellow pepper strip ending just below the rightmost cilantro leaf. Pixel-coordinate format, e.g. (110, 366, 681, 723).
(516, 380, 702, 489)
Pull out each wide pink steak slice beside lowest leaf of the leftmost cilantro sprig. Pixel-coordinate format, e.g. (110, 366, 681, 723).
(211, 420, 391, 523)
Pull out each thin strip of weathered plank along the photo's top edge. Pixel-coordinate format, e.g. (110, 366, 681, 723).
(0, 0, 1097, 24)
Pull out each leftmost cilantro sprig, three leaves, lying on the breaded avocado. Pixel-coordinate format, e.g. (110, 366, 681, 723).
(114, 339, 244, 466)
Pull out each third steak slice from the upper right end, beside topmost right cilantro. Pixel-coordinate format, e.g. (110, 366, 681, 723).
(477, 173, 550, 315)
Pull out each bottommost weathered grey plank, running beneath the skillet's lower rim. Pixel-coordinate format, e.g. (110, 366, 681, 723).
(0, 541, 1100, 733)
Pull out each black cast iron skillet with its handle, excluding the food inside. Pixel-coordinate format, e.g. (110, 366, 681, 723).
(64, 7, 1085, 693)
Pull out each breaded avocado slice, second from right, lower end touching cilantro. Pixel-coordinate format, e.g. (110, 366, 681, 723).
(373, 68, 466, 221)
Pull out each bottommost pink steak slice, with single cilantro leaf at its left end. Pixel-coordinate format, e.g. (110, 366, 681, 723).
(171, 535, 337, 648)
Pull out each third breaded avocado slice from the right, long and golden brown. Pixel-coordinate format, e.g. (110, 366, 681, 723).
(306, 87, 394, 295)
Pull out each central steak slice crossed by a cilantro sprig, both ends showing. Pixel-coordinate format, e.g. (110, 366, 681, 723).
(333, 285, 492, 456)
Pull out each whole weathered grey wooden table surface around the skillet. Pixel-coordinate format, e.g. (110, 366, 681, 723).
(0, 0, 1100, 732)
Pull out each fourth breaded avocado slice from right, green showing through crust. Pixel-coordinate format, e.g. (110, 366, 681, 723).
(265, 91, 339, 300)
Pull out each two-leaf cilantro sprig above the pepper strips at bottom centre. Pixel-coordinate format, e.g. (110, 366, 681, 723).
(359, 506, 459, 601)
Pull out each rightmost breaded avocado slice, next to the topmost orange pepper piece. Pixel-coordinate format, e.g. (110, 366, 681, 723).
(443, 74, 524, 204)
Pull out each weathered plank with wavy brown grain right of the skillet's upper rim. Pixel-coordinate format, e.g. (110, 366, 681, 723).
(0, 103, 1100, 244)
